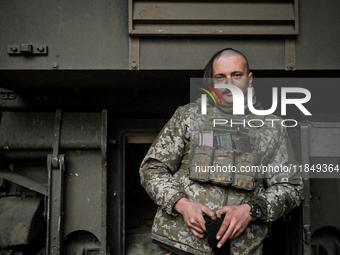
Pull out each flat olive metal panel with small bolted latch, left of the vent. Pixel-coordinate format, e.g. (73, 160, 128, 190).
(0, 0, 128, 70)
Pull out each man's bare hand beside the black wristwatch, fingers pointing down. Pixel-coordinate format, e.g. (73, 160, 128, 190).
(216, 204, 253, 248)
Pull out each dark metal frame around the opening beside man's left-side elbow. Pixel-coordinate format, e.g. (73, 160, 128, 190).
(107, 119, 167, 254)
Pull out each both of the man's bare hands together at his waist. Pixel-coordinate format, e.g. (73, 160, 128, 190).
(175, 198, 252, 248)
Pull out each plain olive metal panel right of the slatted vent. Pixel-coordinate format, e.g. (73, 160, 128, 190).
(296, 0, 340, 70)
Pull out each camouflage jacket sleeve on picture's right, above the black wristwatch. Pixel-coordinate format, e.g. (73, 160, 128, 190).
(251, 121, 304, 221)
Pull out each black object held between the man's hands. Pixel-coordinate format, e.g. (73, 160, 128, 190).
(203, 215, 230, 255)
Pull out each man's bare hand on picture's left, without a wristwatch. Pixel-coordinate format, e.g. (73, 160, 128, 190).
(175, 198, 216, 238)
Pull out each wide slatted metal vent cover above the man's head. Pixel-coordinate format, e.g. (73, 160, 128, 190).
(129, 0, 298, 36)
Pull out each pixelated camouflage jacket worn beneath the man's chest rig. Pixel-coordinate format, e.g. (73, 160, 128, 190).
(140, 104, 303, 255)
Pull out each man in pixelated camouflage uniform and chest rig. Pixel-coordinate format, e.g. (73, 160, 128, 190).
(140, 48, 303, 255)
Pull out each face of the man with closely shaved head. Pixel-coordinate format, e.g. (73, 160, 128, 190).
(213, 55, 253, 103)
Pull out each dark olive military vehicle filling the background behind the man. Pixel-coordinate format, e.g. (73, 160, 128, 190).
(0, 0, 340, 255)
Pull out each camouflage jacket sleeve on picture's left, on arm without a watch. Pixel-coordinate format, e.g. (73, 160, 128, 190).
(139, 106, 190, 216)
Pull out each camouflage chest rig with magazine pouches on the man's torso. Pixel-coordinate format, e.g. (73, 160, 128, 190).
(188, 108, 263, 191)
